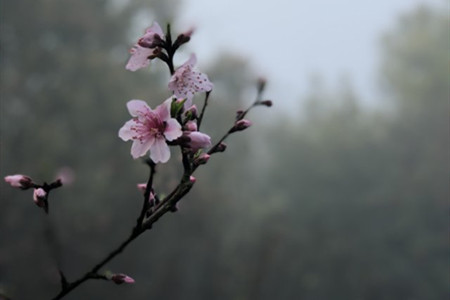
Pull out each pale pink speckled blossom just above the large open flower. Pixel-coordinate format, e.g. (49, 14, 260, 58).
(169, 54, 213, 108)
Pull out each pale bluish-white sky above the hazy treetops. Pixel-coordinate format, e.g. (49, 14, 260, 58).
(176, 0, 444, 111)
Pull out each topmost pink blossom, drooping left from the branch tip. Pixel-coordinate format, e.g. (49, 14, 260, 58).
(125, 22, 164, 71)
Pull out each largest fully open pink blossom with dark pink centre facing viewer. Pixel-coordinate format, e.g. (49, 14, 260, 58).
(119, 98, 182, 163)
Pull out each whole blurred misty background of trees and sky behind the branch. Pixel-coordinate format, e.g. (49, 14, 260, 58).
(0, 0, 450, 300)
